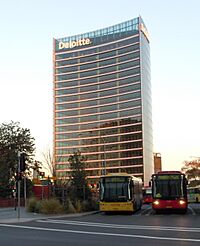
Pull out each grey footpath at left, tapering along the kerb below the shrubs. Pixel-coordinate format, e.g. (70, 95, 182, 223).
(0, 207, 96, 224)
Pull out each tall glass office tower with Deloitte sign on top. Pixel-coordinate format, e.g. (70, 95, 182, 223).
(53, 17, 153, 183)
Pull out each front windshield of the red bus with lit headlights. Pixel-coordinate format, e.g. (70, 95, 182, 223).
(153, 175, 184, 199)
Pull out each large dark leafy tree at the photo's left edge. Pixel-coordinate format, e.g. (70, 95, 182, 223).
(0, 121, 35, 197)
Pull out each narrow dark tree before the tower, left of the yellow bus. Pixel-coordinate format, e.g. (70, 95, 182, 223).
(68, 151, 90, 200)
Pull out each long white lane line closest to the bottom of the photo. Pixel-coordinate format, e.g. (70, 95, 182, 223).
(0, 224, 200, 242)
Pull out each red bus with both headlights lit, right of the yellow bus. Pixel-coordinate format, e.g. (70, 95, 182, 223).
(152, 171, 188, 213)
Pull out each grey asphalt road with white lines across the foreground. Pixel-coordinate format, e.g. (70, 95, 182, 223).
(0, 204, 200, 246)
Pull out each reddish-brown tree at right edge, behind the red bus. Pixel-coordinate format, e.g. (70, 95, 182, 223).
(181, 159, 200, 186)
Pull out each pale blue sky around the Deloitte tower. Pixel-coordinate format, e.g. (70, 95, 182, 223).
(0, 0, 200, 170)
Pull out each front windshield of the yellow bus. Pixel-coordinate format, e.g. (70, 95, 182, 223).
(100, 177, 130, 202)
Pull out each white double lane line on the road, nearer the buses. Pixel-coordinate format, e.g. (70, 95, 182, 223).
(37, 219, 200, 233)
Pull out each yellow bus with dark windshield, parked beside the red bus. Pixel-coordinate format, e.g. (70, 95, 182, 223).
(99, 173, 142, 212)
